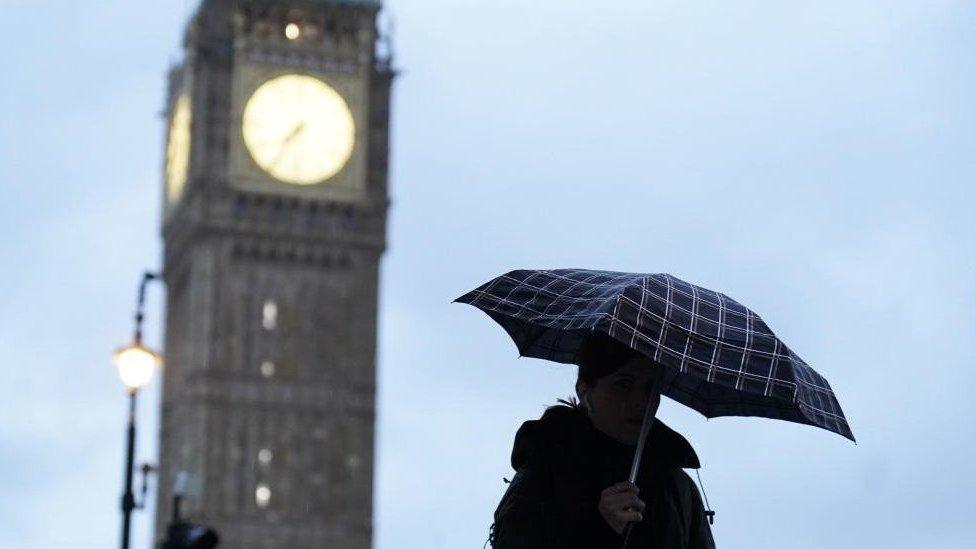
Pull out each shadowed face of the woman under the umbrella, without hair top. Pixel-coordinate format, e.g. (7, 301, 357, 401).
(576, 357, 662, 444)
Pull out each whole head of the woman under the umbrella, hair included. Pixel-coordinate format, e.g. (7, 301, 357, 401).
(576, 332, 663, 444)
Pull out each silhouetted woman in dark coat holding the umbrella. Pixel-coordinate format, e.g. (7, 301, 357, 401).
(489, 332, 715, 549)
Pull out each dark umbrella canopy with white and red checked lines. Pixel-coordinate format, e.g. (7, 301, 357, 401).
(455, 269, 854, 440)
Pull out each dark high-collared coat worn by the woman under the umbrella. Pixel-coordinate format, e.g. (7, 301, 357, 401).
(489, 405, 715, 549)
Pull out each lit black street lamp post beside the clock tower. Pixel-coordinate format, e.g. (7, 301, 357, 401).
(112, 272, 162, 549)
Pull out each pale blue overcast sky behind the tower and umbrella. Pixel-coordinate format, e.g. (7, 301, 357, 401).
(0, 0, 976, 549)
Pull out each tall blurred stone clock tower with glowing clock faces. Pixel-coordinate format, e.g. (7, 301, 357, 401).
(156, 0, 393, 549)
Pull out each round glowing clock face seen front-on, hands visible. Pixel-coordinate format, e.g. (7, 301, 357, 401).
(242, 74, 356, 185)
